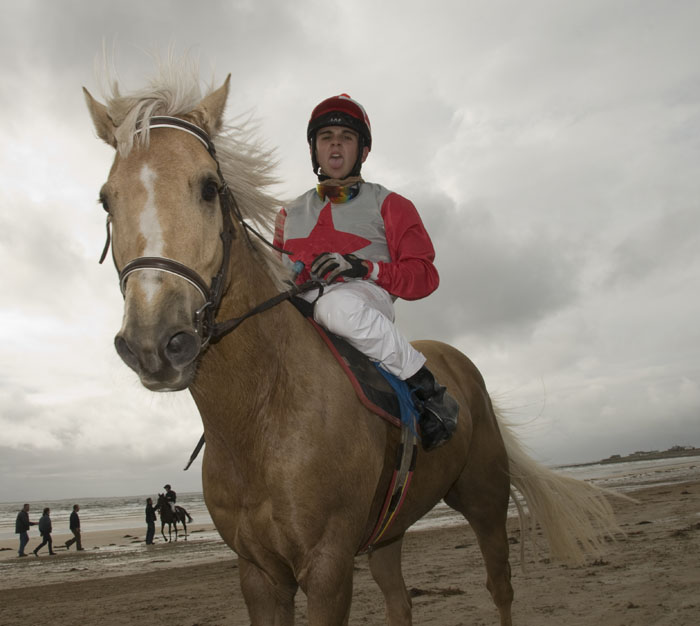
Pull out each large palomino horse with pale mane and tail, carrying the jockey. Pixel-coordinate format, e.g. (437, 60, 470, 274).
(85, 68, 616, 626)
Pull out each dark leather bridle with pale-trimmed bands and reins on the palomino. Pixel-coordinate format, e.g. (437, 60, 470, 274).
(100, 115, 322, 351)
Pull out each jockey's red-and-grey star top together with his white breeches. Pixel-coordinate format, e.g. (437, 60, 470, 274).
(275, 178, 439, 380)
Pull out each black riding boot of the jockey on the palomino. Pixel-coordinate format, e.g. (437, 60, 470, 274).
(406, 366, 459, 451)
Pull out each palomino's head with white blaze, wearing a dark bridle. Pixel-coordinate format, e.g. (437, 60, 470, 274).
(85, 79, 235, 391)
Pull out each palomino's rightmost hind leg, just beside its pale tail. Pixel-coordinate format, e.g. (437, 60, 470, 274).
(445, 442, 513, 626)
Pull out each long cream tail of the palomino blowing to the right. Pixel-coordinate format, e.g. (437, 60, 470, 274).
(495, 409, 625, 563)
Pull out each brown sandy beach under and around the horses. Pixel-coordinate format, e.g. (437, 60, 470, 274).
(0, 459, 700, 626)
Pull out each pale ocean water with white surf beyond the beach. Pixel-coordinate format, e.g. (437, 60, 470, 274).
(0, 457, 700, 540)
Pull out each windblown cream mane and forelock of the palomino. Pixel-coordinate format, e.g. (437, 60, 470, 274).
(98, 54, 289, 282)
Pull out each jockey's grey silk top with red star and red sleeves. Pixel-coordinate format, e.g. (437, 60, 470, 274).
(274, 183, 439, 300)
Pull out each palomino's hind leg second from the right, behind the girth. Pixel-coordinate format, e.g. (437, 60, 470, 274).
(369, 535, 412, 626)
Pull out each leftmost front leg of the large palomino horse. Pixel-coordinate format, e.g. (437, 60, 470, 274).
(238, 556, 297, 626)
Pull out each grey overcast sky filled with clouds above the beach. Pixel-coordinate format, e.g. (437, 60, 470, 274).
(0, 0, 700, 501)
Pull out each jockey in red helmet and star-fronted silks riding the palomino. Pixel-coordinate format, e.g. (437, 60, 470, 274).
(275, 94, 459, 450)
